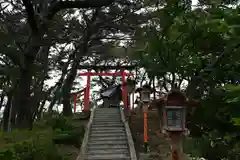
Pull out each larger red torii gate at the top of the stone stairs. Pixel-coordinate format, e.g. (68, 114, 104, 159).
(79, 71, 133, 112)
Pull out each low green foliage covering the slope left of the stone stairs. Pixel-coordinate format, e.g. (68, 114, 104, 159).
(0, 116, 84, 160)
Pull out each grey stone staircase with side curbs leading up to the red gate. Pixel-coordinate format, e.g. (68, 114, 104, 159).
(77, 107, 137, 160)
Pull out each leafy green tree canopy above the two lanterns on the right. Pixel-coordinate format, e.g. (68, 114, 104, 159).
(135, 2, 240, 92)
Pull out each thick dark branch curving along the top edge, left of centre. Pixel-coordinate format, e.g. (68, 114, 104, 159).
(47, 0, 114, 19)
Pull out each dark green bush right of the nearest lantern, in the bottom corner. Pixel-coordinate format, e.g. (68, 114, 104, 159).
(185, 85, 240, 160)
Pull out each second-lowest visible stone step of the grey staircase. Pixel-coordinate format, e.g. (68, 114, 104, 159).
(87, 148, 129, 155)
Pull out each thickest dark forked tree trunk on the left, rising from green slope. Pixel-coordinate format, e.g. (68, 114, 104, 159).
(13, 42, 49, 129)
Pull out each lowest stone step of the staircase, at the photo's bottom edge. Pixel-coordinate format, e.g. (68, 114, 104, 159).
(86, 153, 130, 160)
